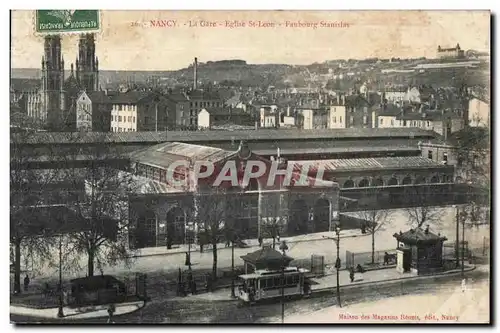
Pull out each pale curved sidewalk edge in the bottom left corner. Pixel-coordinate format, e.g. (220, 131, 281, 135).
(10, 301, 144, 320)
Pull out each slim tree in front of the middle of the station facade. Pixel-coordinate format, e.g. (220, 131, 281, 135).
(195, 188, 230, 281)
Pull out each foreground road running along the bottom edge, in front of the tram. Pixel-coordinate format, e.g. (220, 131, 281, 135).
(11, 266, 489, 324)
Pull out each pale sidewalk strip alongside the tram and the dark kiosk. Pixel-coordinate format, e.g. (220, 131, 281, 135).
(179, 265, 475, 301)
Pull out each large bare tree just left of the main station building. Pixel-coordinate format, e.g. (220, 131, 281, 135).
(65, 133, 138, 276)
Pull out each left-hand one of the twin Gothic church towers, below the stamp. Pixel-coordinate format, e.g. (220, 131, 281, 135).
(41, 35, 65, 128)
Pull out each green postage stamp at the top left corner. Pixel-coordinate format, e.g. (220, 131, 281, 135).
(35, 9, 101, 33)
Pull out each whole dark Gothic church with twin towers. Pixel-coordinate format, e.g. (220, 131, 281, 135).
(26, 34, 99, 131)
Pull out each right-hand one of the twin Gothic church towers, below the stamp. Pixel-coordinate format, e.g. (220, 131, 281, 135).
(76, 34, 99, 92)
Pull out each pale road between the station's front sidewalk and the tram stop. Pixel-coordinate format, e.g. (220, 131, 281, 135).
(18, 207, 490, 280)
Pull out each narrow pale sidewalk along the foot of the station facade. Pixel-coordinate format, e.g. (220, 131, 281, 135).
(130, 229, 369, 258)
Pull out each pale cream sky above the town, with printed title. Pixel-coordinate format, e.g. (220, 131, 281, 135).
(11, 10, 490, 70)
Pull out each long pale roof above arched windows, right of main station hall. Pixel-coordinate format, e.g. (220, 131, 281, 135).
(288, 156, 443, 171)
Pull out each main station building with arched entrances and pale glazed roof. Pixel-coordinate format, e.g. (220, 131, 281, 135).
(130, 142, 339, 248)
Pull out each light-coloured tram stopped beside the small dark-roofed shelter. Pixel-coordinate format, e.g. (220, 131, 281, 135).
(237, 267, 310, 303)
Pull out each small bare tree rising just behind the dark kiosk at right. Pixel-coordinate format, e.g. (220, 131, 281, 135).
(405, 186, 443, 229)
